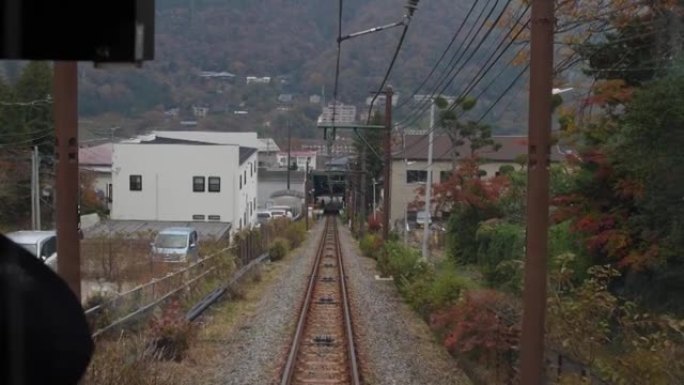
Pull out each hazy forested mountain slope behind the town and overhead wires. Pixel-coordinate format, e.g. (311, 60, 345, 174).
(72, 0, 526, 136)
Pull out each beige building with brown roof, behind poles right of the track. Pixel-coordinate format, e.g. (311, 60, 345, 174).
(390, 134, 563, 226)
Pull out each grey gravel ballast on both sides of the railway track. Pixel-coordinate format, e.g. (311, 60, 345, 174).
(194, 221, 471, 385)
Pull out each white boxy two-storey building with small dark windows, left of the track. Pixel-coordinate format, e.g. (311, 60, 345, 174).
(111, 136, 258, 233)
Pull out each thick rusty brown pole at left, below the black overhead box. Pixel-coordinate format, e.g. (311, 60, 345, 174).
(53, 62, 81, 300)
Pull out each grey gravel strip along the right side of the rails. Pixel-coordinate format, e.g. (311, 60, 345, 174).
(339, 222, 471, 385)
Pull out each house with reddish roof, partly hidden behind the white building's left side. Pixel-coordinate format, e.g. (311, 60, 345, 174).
(78, 143, 113, 209)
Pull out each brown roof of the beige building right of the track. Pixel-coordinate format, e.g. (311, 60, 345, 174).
(392, 135, 563, 162)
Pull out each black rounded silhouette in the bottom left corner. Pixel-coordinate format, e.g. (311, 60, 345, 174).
(0, 234, 94, 385)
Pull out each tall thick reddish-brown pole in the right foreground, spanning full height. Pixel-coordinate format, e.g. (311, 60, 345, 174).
(520, 0, 554, 385)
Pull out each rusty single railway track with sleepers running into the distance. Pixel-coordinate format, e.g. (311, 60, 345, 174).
(280, 215, 361, 385)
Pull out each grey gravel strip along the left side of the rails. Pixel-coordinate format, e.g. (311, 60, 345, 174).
(204, 221, 323, 385)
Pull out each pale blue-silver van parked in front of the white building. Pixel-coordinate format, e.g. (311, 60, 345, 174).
(150, 227, 199, 263)
